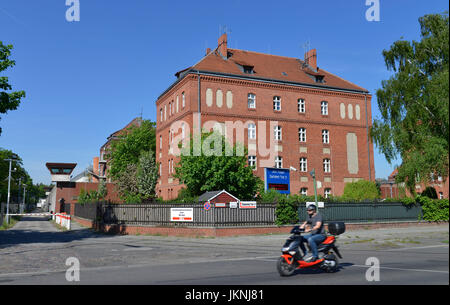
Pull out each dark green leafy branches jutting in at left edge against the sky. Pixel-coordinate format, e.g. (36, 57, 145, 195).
(0, 41, 25, 134)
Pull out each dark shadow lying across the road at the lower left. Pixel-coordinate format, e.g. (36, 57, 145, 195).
(0, 217, 113, 250)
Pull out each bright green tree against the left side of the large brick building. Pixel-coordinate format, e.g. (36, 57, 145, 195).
(106, 120, 156, 181)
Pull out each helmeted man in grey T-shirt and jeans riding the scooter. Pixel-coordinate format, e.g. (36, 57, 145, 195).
(300, 204, 326, 262)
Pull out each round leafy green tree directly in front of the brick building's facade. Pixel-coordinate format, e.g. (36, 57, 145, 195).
(174, 133, 262, 200)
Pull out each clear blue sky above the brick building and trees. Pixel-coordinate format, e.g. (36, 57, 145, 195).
(0, 0, 448, 184)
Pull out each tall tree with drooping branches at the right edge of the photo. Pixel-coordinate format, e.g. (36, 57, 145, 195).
(371, 12, 449, 193)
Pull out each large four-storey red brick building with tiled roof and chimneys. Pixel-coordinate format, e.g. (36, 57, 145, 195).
(156, 34, 375, 200)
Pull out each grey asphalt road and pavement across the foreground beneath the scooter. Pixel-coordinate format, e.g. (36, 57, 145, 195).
(0, 214, 449, 285)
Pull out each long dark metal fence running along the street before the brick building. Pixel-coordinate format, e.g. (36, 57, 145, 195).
(74, 202, 422, 227)
